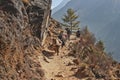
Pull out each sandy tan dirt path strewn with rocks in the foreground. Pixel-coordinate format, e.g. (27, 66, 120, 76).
(40, 46, 79, 80)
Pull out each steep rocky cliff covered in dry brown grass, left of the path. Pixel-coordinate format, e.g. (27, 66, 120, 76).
(0, 0, 51, 80)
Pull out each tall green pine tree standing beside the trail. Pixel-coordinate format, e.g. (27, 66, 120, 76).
(62, 8, 80, 32)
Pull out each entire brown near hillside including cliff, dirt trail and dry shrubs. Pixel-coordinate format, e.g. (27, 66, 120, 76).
(0, 0, 120, 80)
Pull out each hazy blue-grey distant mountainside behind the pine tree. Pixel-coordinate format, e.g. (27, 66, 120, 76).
(52, 0, 120, 61)
